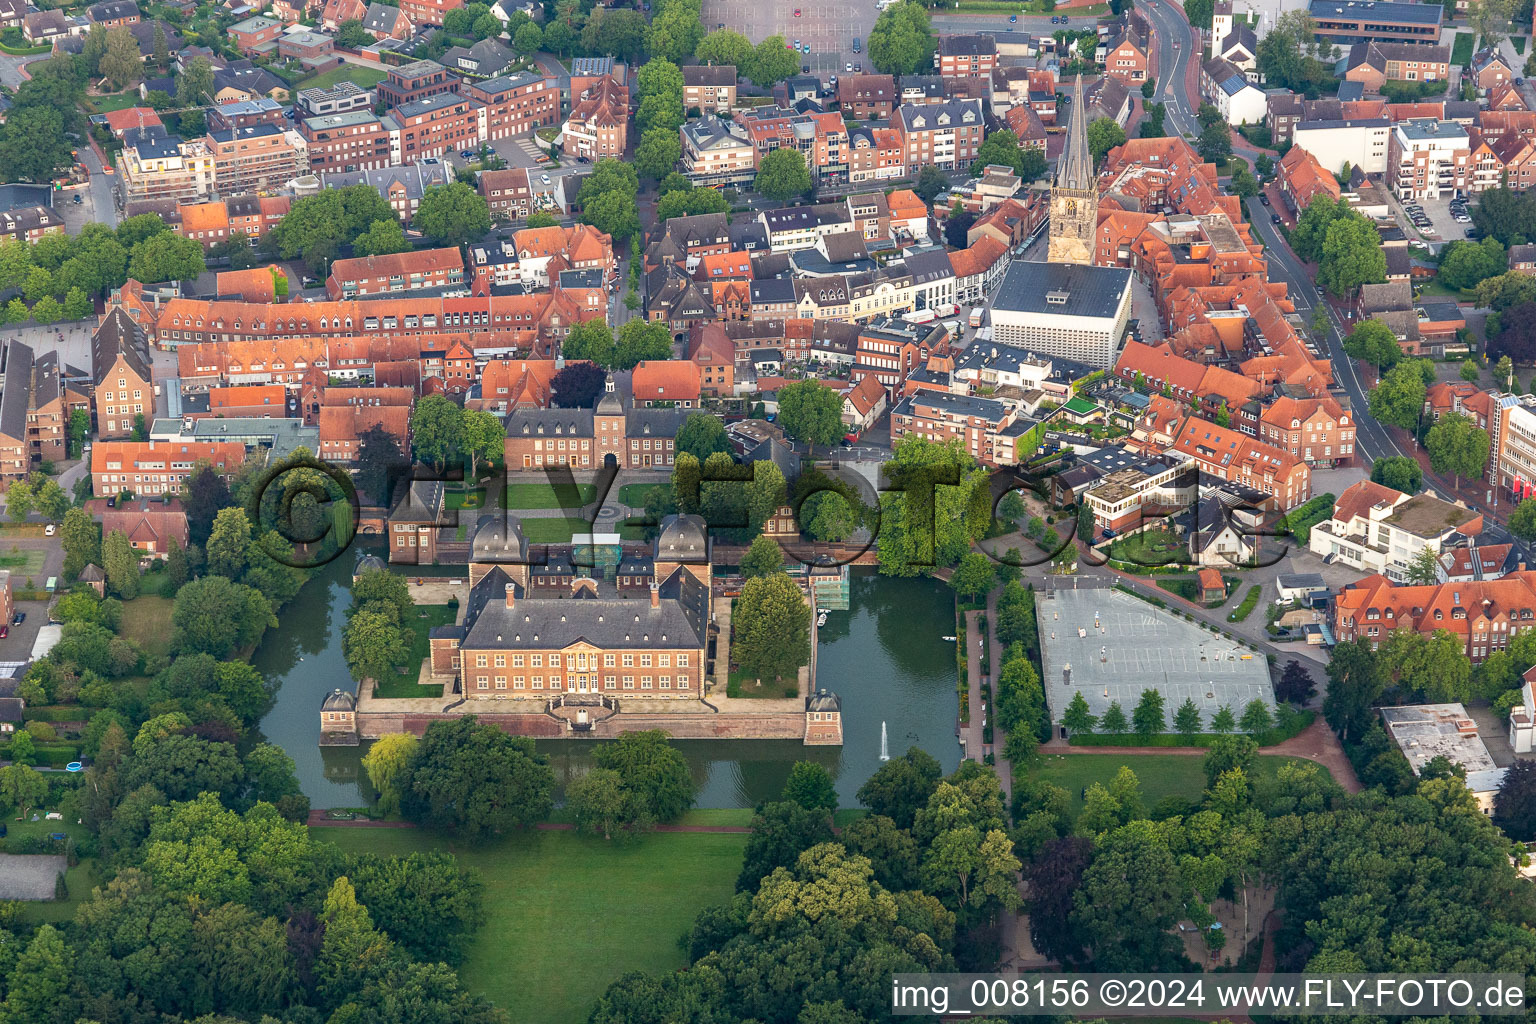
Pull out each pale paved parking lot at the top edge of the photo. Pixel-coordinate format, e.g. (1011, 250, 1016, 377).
(700, 0, 876, 78)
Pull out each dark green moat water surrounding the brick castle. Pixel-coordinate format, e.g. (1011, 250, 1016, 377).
(252, 556, 960, 808)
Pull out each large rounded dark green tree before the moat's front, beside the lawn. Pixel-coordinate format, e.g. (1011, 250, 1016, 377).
(401, 715, 554, 840)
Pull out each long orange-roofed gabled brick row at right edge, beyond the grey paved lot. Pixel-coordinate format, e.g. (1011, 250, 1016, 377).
(1333, 571, 1536, 665)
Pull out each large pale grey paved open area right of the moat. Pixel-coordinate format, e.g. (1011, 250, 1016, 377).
(1035, 590, 1275, 732)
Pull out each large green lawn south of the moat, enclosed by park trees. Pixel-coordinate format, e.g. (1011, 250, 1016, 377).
(310, 827, 746, 1024)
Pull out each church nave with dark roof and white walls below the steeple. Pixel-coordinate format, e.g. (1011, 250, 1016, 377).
(992, 261, 1130, 367)
